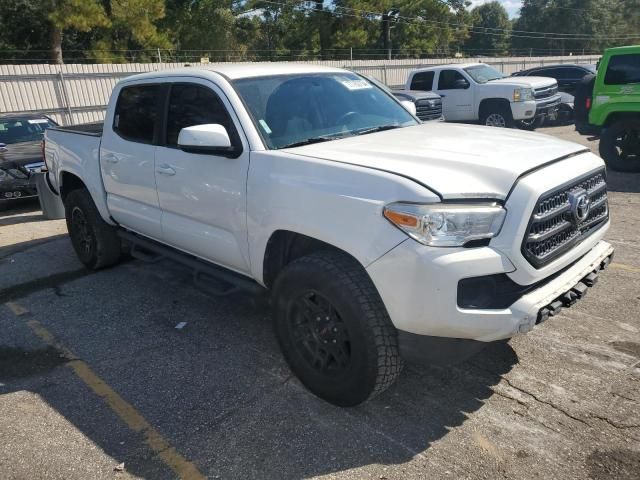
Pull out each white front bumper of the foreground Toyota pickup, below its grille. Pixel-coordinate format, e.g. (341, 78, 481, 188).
(367, 240, 613, 342)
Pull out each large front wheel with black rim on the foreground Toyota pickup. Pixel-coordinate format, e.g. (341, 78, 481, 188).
(273, 251, 403, 406)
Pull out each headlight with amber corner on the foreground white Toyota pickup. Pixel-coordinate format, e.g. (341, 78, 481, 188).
(383, 203, 506, 247)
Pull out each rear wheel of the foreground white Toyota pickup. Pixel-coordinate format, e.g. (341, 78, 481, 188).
(64, 189, 122, 270)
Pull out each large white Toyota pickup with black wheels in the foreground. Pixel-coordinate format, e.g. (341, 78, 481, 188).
(44, 65, 613, 406)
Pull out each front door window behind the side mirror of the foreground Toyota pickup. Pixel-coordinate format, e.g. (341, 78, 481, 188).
(166, 84, 237, 146)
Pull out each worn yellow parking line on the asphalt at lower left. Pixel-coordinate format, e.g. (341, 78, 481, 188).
(6, 303, 206, 480)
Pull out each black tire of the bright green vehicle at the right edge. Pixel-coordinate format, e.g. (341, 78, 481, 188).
(600, 119, 640, 172)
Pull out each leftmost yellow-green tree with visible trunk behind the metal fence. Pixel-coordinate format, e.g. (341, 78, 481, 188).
(48, 0, 110, 64)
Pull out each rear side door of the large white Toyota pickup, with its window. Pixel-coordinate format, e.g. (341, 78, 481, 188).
(100, 84, 163, 239)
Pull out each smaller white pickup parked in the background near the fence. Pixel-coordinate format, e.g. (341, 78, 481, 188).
(406, 63, 560, 129)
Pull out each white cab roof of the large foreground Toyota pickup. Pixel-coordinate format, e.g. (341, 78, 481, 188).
(120, 62, 345, 81)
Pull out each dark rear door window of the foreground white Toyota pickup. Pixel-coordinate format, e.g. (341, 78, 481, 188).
(113, 85, 160, 143)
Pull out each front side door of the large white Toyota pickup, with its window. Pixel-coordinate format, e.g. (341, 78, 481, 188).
(155, 79, 250, 273)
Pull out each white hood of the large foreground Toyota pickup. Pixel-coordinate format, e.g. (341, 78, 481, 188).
(286, 123, 586, 199)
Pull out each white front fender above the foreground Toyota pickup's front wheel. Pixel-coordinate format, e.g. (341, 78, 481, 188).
(247, 151, 439, 284)
